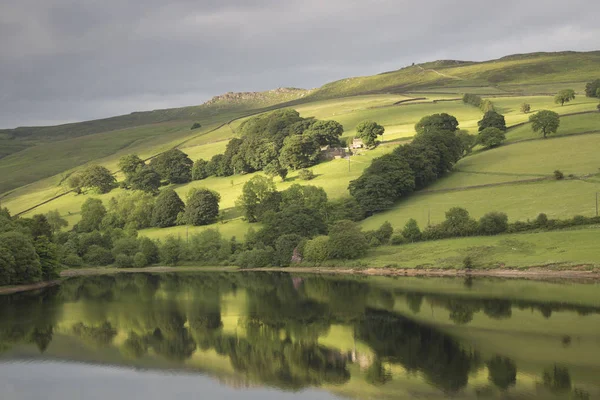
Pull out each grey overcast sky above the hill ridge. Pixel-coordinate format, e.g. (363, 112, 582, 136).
(0, 0, 600, 128)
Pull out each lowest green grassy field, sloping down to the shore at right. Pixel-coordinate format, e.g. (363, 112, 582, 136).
(361, 226, 600, 268)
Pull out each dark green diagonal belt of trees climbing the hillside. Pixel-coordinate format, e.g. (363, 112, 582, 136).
(349, 114, 472, 215)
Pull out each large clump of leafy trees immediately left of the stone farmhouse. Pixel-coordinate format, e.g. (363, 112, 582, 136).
(192, 109, 344, 184)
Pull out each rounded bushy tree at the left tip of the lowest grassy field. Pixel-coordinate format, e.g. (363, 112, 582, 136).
(329, 221, 369, 260)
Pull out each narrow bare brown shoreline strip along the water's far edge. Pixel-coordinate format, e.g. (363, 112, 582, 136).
(0, 266, 600, 295)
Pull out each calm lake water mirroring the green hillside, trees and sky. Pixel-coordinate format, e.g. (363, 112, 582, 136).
(0, 273, 600, 400)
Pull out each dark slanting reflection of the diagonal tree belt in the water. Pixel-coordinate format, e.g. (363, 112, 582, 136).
(356, 309, 476, 392)
